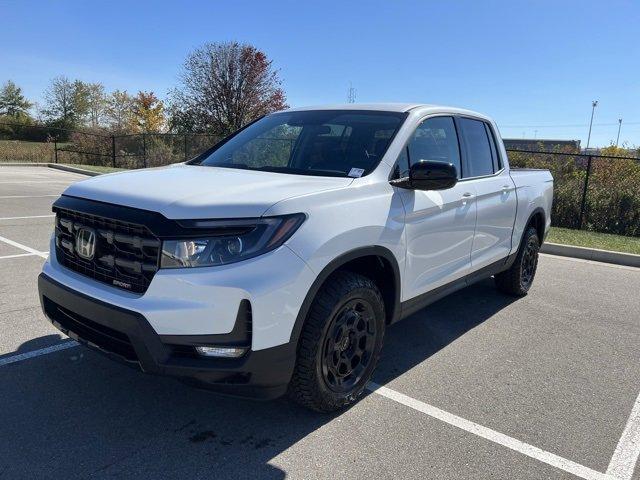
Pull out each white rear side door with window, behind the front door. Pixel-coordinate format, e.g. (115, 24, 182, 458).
(456, 117, 517, 271)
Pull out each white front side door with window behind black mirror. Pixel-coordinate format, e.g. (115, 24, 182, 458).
(398, 116, 476, 300)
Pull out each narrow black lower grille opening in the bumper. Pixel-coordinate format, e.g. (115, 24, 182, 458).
(43, 297, 138, 362)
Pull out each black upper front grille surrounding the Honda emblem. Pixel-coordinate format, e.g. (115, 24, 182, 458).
(56, 208, 160, 293)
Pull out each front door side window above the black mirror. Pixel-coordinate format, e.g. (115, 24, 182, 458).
(409, 117, 461, 178)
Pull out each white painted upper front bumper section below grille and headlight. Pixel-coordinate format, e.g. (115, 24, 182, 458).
(42, 232, 316, 351)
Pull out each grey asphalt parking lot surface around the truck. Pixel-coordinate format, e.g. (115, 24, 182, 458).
(0, 166, 640, 480)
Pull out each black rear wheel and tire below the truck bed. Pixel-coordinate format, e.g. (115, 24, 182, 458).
(495, 227, 540, 297)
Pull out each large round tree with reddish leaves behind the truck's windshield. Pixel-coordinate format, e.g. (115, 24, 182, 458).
(169, 42, 287, 135)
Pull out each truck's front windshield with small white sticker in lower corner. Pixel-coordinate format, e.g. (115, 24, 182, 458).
(190, 110, 406, 177)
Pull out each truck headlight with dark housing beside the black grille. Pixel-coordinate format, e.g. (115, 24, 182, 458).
(160, 213, 305, 268)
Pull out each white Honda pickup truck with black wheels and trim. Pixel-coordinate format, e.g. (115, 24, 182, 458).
(39, 104, 553, 411)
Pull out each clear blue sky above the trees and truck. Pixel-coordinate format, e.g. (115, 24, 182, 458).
(0, 0, 640, 146)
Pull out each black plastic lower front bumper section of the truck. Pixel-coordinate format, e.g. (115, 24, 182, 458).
(38, 273, 295, 399)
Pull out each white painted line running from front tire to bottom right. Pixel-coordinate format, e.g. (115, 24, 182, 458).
(367, 382, 612, 480)
